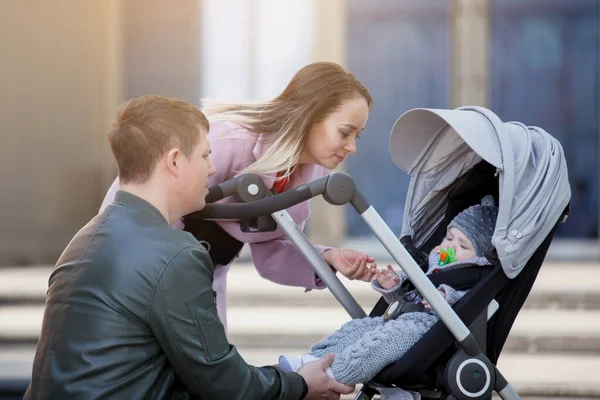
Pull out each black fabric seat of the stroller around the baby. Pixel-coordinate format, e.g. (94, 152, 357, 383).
(369, 161, 568, 398)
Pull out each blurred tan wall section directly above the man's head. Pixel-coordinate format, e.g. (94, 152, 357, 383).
(123, 0, 202, 104)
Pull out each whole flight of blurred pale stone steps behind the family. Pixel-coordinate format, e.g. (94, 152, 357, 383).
(0, 262, 600, 399)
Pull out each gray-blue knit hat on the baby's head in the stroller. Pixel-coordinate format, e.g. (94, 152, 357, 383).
(447, 195, 498, 257)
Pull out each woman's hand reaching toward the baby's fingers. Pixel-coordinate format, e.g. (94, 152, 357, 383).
(321, 249, 377, 282)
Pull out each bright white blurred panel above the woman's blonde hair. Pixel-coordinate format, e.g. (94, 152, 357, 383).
(201, 0, 313, 101)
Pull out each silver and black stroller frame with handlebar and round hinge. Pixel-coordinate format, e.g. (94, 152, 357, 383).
(194, 172, 520, 400)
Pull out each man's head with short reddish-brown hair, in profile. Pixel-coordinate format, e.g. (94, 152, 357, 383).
(108, 96, 215, 212)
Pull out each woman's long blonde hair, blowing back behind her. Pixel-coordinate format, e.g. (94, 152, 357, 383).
(201, 62, 373, 176)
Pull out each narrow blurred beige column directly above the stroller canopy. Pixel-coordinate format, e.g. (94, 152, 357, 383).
(452, 0, 490, 107)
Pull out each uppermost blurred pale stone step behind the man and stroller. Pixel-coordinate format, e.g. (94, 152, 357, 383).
(0, 263, 600, 310)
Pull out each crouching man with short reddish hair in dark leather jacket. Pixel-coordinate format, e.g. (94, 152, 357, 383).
(25, 96, 353, 400)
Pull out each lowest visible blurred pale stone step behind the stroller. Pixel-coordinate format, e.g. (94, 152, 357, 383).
(0, 346, 600, 400)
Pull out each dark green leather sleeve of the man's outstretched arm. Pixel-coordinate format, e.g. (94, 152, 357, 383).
(149, 246, 303, 400)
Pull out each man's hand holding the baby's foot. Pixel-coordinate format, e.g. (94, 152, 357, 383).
(298, 353, 354, 400)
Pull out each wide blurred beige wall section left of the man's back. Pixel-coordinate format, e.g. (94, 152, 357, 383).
(0, 0, 122, 265)
